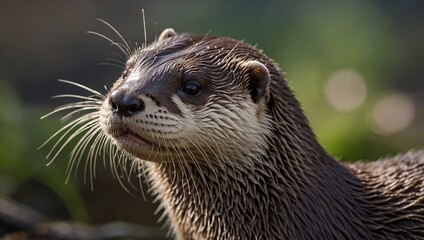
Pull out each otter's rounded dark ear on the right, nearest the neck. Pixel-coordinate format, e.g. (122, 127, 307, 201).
(243, 60, 270, 102)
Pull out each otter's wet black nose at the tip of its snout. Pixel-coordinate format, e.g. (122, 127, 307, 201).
(109, 89, 145, 117)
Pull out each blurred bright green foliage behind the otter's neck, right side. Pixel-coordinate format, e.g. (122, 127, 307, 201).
(276, 1, 396, 160)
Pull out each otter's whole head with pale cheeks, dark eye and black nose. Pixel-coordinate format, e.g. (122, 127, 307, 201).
(100, 29, 270, 162)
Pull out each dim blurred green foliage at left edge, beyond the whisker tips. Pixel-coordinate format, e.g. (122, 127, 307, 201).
(0, 81, 87, 220)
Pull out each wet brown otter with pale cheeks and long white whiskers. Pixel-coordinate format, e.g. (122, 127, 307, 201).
(45, 29, 424, 239)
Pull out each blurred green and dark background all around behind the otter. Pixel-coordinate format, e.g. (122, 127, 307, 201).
(0, 0, 424, 238)
